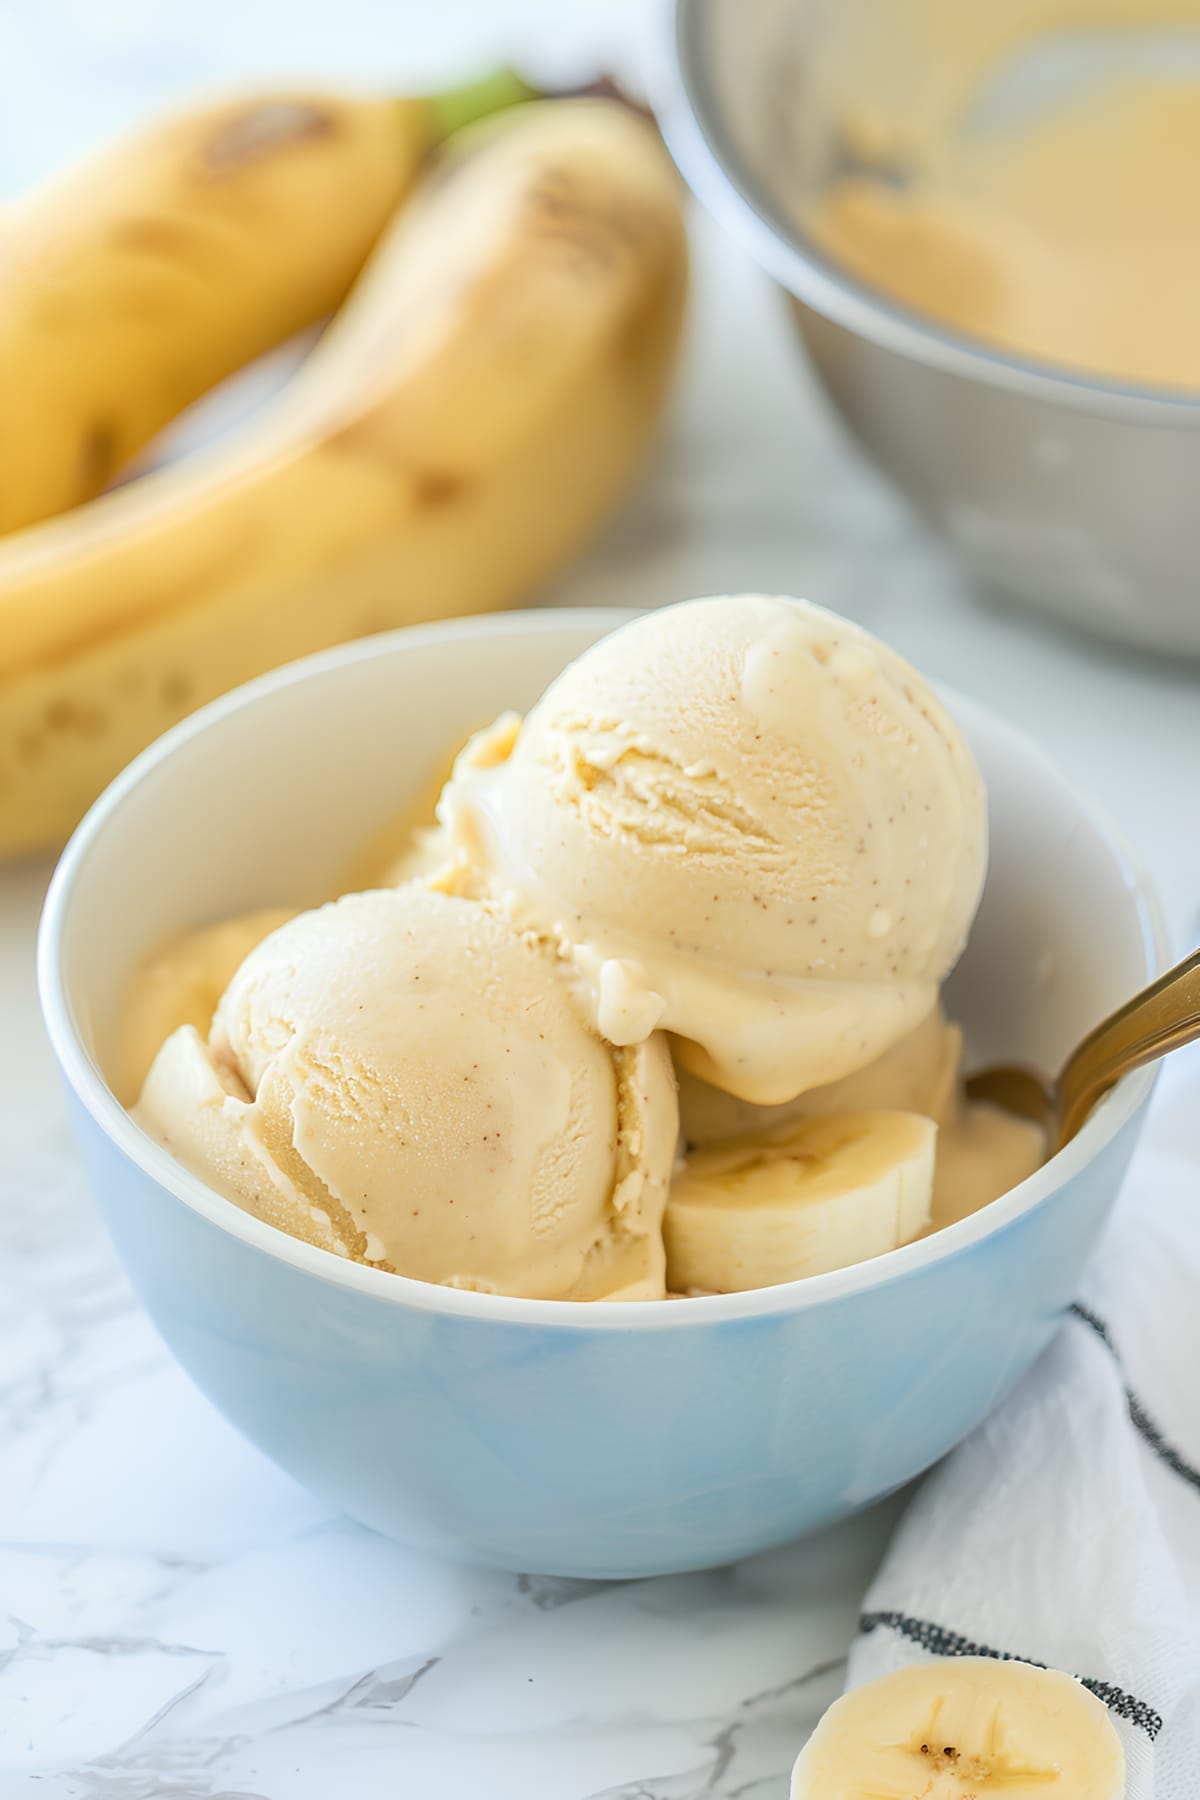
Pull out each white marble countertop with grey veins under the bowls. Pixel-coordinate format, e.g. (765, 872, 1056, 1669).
(0, 0, 1200, 1800)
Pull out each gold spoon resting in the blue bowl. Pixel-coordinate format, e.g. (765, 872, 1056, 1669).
(966, 950, 1200, 1156)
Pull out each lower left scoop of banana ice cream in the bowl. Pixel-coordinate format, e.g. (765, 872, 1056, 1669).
(135, 884, 678, 1300)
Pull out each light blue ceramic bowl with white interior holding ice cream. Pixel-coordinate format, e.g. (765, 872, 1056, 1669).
(40, 612, 1160, 1577)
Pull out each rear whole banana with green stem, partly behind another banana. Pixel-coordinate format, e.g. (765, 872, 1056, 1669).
(0, 74, 527, 531)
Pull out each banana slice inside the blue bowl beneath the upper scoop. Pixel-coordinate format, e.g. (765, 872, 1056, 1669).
(664, 1112, 937, 1294)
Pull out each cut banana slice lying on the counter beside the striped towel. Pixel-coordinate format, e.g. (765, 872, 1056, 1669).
(792, 1656, 1124, 1800)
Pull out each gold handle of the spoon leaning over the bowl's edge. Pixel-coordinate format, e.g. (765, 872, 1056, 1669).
(1058, 950, 1200, 1145)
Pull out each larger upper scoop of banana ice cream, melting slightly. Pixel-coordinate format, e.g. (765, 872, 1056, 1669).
(441, 596, 988, 1105)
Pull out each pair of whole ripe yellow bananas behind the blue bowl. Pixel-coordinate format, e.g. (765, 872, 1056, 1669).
(0, 77, 687, 853)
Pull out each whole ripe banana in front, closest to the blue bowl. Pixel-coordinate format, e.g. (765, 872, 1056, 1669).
(0, 101, 687, 853)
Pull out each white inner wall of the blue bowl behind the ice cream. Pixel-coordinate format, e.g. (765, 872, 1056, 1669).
(59, 612, 1157, 1108)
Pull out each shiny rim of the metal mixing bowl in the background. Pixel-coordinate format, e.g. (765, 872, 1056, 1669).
(644, 0, 1200, 430)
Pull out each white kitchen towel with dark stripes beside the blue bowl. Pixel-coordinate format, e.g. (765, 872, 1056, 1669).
(849, 1051, 1200, 1800)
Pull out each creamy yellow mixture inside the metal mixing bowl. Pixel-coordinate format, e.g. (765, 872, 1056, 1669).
(802, 0, 1200, 389)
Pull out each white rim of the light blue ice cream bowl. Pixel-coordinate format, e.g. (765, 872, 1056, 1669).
(36, 607, 1168, 1332)
